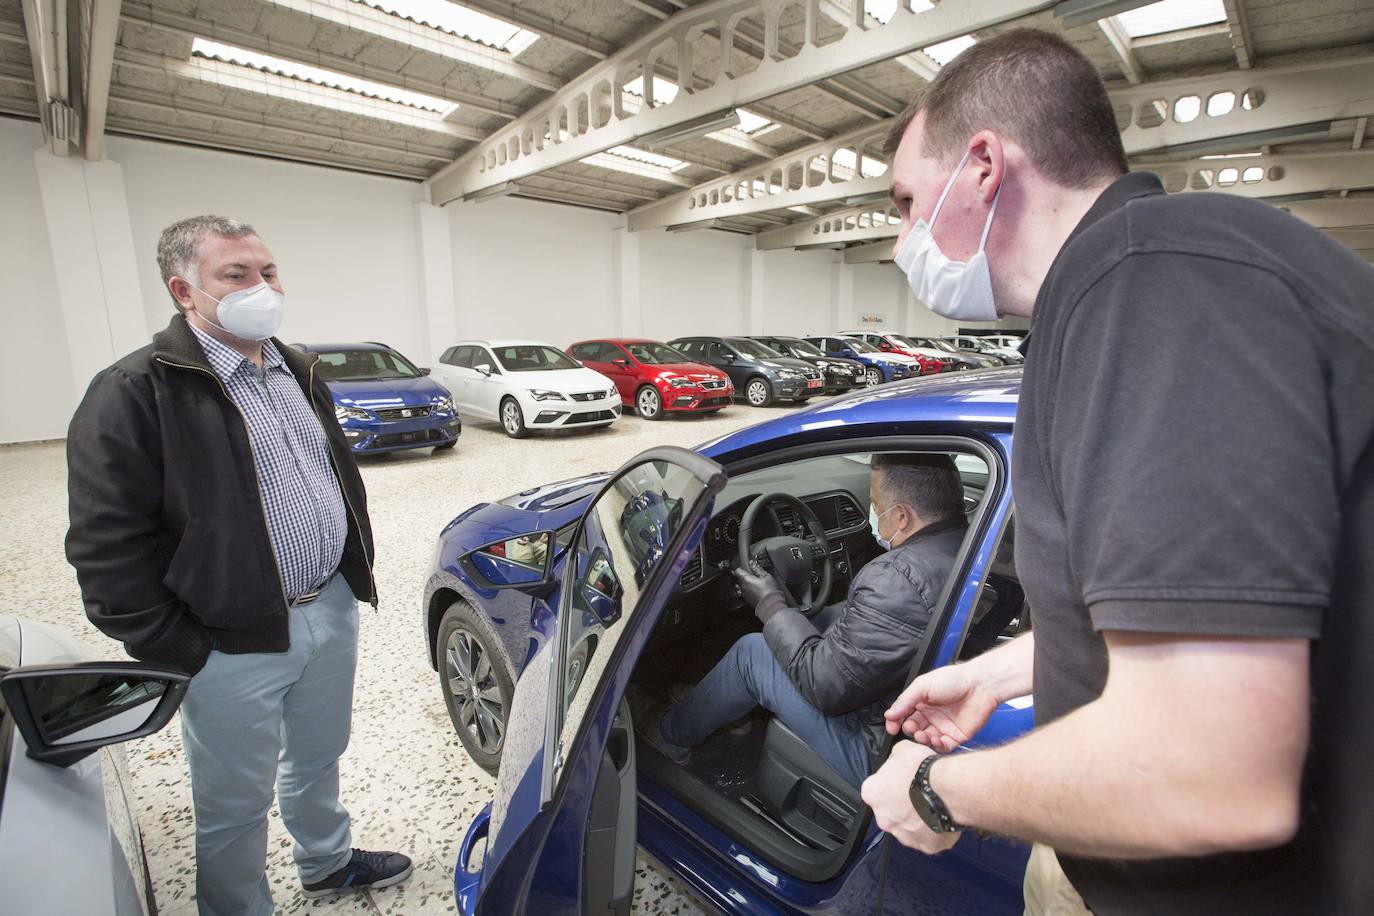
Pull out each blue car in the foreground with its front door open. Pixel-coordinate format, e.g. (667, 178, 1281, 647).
(422, 368, 1032, 913)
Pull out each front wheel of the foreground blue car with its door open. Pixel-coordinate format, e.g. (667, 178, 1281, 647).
(436, 600, 515, 776)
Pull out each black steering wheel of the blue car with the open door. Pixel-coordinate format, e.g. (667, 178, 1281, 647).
(739, 493, 834, 614)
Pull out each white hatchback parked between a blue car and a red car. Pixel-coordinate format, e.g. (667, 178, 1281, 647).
(430, 341, 620, 439)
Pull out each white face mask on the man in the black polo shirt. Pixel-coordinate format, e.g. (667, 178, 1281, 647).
(896, 152, 1006, 321)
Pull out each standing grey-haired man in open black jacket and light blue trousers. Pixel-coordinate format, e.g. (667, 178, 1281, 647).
(67, 216, 411, 916)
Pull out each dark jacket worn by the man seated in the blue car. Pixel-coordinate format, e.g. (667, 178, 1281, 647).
(764, 515, 967, 754)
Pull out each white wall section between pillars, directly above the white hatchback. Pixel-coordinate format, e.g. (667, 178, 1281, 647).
(445, 198, 620, 348)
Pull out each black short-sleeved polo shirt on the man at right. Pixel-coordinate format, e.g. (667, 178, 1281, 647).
(1013, 173, 1374, 913)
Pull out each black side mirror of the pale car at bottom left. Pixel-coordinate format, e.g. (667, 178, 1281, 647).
(0, 662, 191, 766)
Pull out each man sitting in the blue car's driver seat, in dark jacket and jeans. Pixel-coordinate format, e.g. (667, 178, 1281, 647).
(646, 455, 966, 787)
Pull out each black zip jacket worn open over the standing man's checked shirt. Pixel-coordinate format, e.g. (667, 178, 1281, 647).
(67, 316, 376, 674)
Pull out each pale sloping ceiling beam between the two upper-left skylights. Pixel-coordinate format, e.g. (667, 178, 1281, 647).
(262, 0, 562, 92)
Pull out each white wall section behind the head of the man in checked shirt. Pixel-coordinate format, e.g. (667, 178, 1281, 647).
(106, 137, 427, 365)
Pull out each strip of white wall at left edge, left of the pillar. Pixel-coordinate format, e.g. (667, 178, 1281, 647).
(0, 118, 76, 442)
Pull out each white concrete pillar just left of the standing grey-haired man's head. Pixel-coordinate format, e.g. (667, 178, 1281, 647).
(33, 148, 151, 397)
